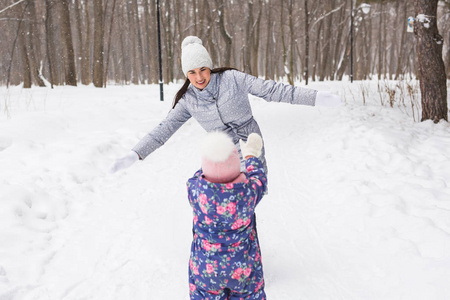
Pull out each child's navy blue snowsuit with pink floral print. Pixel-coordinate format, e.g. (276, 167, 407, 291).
(187, 157, 267, 300)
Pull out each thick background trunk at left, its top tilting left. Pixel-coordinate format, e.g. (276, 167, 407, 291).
(60, 0, 77, 86)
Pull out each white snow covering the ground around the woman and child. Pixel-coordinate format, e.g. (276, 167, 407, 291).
(0, 81, 450, 300)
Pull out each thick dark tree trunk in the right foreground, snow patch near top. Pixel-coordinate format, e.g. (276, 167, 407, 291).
(414, 0, 448, 123)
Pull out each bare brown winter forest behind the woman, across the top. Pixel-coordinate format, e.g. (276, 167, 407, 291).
(0, 0, 450, 87)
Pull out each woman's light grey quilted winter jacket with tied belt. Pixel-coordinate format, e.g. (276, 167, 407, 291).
(133, 70, 317, 170)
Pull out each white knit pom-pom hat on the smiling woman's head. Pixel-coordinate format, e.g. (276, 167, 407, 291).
(181, 36, 212, 76)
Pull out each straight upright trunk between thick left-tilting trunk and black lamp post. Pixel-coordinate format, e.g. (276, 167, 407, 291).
(93, 0, 104, 87)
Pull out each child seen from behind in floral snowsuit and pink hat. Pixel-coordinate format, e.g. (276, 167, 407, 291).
(187, 132, 267, 300)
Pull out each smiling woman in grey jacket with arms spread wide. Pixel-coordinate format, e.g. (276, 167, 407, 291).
(111, 36, 341, 172)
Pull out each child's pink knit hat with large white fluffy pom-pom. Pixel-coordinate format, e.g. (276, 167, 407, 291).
(201, 131, 241, 183)
